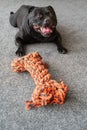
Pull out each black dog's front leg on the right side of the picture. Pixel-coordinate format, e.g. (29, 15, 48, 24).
(54, 31, 67, 54)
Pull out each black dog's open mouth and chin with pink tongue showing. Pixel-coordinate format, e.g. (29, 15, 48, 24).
(33, 25, 54, 37)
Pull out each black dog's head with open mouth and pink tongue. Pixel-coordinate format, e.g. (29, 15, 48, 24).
(28, 6, 57, 37)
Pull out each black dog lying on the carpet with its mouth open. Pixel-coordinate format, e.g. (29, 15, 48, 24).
(10, 5, 67, 56)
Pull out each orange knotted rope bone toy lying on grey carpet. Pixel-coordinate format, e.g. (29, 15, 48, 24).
(11, 52, 68, 110)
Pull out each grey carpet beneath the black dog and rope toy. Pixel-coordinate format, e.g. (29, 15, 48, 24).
(0, 0, 87, 130)
